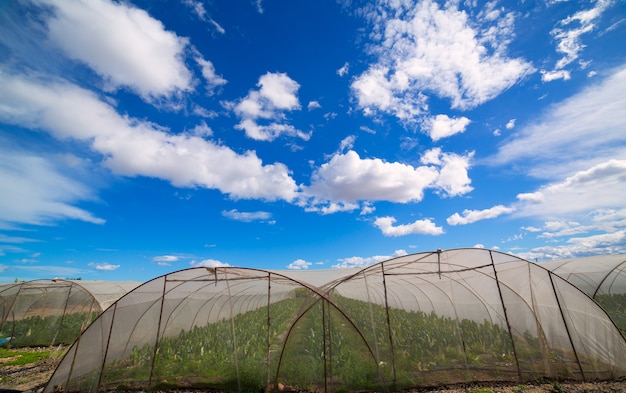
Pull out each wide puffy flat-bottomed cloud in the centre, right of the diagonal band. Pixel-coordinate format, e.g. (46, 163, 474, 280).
(303, 149, 472, 211)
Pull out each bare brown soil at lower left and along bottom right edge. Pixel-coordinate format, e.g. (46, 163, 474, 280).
(0, 349, 626, 393)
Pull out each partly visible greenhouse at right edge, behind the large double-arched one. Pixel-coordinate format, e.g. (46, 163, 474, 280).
(540, 254, 626, 332)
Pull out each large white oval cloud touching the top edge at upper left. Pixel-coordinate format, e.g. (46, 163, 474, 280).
(39, 0, 192, 100)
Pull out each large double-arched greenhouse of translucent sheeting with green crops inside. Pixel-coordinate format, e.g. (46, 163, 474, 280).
(45, 249, 626, 392)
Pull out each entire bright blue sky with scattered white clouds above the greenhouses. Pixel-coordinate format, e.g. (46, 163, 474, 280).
(0, 0, 626, 282)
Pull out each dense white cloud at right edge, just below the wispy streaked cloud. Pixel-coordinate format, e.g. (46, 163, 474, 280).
(516, 160, 626, 217)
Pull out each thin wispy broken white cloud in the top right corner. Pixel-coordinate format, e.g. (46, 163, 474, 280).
(542, 0, 611, 82)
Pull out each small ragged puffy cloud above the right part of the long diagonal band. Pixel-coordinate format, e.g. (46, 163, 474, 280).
(231, 72, 310, 141)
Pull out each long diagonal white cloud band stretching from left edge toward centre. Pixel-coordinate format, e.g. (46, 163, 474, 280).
(0, 74, 298, 201)
